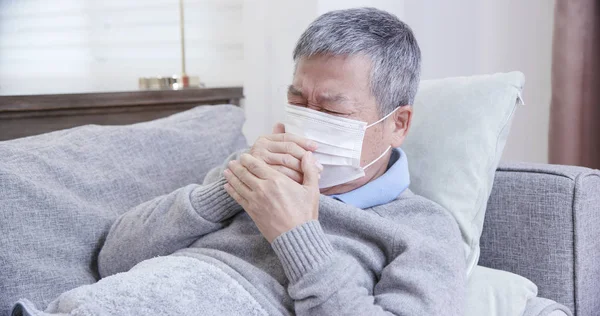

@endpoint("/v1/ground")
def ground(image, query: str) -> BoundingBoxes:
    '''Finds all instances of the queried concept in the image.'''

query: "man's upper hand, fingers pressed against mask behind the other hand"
[249,123,323,183]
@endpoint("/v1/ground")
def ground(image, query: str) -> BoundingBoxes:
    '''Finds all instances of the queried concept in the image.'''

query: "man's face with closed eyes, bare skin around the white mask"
[288,56,410,194]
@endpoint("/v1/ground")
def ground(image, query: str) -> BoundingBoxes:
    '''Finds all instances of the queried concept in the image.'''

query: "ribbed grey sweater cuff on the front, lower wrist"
[271,221,333,283]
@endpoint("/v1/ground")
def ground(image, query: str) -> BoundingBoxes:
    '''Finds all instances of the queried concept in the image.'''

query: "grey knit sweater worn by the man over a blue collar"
[98,154,466,315]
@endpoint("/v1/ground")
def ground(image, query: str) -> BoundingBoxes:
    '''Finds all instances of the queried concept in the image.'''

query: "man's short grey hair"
[294,8,421,116]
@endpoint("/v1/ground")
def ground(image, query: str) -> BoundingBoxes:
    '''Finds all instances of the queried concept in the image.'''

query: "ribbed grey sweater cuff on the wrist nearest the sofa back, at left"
[190,176,242,223]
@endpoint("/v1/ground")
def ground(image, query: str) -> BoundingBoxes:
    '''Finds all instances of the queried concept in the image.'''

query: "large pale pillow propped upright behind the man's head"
[402,72,525,275]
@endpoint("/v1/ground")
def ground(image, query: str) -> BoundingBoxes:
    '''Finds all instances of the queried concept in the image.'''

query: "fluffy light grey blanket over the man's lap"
[13,256,267,316]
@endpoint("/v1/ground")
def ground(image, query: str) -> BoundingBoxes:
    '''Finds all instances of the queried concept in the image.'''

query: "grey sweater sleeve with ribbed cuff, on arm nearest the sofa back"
[98,153,242,277]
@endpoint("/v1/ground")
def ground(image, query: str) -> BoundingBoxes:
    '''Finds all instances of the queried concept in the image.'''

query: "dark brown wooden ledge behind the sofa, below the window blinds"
[0,87,243,141]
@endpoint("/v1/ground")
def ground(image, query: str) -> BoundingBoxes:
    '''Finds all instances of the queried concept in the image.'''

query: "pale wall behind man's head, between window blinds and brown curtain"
[244,0,554,162]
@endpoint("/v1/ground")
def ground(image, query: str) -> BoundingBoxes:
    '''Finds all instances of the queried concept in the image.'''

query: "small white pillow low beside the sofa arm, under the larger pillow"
[466,266,537,316]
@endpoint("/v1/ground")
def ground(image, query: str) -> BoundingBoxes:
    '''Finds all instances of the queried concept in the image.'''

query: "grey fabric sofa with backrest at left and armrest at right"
[0,106,600,316]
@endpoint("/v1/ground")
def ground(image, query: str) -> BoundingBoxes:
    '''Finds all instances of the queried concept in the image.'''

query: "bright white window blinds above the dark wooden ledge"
[0,0,243,95]
